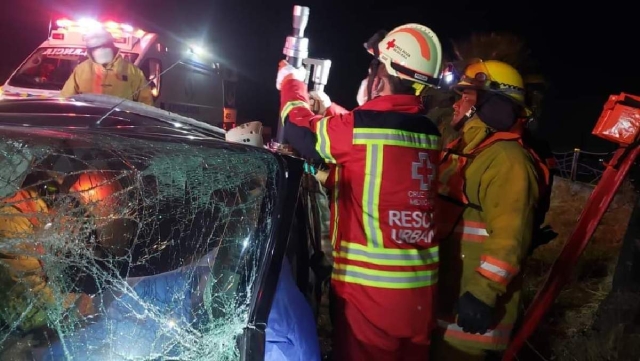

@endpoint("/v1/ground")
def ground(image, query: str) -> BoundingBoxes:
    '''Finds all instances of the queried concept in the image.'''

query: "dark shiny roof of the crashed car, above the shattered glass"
[0,94,226,140]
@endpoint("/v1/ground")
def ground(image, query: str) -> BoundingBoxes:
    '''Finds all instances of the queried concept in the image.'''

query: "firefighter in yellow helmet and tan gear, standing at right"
[432,61,549,361]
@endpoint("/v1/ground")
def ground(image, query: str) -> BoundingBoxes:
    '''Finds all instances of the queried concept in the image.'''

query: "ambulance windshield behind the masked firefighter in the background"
[9,47,138,91]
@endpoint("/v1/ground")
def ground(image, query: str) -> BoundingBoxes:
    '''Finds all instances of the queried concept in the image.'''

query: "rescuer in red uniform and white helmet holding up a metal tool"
[276,24,442,361]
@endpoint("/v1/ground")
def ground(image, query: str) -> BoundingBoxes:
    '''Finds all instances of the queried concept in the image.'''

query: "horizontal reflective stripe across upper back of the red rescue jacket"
[353,128,440,149]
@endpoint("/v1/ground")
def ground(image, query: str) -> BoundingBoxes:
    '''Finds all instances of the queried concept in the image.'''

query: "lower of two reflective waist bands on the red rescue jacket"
[331,263,438,289]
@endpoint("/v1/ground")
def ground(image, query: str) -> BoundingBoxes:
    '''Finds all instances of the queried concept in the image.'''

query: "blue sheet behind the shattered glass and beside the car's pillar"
[37,260,320,361]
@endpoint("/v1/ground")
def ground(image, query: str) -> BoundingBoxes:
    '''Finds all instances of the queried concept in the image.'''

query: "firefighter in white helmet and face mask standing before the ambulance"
[60,28,153,105]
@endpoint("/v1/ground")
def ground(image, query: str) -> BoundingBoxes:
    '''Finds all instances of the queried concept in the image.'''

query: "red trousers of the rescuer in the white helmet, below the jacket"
[331,294,430,361]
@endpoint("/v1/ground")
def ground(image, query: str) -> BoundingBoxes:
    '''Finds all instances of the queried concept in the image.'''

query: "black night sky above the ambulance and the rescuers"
[0,0,640,151]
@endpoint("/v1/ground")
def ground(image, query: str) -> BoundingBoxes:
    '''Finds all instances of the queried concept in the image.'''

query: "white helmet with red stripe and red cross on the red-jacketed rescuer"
[368,23,442,87]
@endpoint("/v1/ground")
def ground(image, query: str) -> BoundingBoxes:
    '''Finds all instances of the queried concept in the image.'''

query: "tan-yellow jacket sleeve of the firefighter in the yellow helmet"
[466,142,538,306]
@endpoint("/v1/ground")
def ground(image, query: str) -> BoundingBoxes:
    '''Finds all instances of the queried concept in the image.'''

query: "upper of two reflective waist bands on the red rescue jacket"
[337,241,439,266]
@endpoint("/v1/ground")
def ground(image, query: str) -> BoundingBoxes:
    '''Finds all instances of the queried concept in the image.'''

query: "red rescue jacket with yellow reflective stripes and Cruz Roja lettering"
[281,79,440,337]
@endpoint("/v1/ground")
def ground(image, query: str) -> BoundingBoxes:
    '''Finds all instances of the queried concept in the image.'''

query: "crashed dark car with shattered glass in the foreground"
[0,95,320,361]
